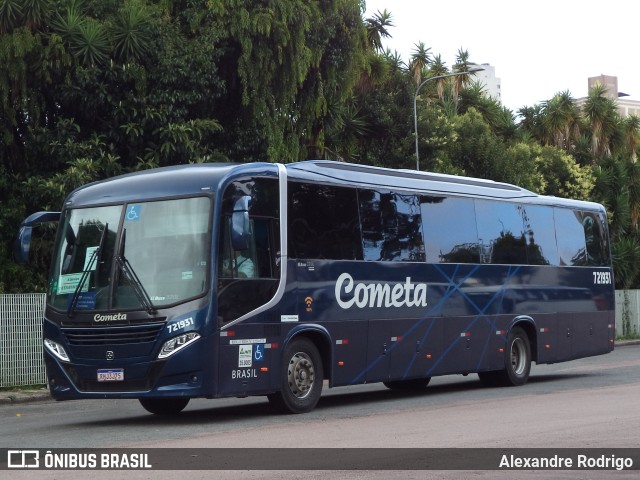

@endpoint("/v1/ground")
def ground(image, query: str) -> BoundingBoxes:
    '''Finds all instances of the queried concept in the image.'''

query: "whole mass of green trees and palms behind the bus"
[0,0,640,292]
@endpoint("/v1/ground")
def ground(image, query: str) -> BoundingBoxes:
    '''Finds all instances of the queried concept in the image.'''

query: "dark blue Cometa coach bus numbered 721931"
[18,161,615,414]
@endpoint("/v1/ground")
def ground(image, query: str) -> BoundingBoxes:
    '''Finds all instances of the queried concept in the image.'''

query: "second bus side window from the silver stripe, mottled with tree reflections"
[359,190,424,262]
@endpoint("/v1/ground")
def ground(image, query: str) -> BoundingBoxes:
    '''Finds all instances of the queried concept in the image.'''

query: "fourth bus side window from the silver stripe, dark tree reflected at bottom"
[475,200,527,264]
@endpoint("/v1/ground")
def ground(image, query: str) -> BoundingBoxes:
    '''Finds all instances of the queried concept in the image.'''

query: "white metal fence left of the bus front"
[0,293,47,387]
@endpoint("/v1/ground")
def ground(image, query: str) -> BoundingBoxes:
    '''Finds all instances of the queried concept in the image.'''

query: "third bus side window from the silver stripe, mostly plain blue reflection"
[420,196,480,263]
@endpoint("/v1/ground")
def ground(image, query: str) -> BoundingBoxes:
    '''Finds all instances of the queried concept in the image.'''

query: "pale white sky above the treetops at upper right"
[365,0,640,112]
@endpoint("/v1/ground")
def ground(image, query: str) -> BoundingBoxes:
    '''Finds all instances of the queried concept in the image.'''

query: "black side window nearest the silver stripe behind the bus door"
[289,182,362,260]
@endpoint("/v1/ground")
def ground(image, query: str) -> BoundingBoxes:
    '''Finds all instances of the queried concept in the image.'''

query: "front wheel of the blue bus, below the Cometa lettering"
[268,338,324,413]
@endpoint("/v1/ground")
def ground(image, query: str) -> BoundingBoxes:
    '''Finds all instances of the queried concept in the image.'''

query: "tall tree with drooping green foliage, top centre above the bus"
[211,0,367,161]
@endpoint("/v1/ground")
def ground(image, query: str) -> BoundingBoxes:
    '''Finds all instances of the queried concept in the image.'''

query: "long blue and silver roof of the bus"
[65,160,603,210]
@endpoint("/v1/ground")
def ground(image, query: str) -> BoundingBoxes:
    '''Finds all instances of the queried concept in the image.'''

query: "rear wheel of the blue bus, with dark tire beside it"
[478,327,531,387]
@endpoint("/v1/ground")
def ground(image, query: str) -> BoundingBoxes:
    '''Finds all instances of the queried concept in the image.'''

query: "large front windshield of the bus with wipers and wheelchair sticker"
[48,197,211,316]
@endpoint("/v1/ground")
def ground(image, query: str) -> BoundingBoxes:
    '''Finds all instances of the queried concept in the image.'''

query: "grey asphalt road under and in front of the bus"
[0,345,640,480]
